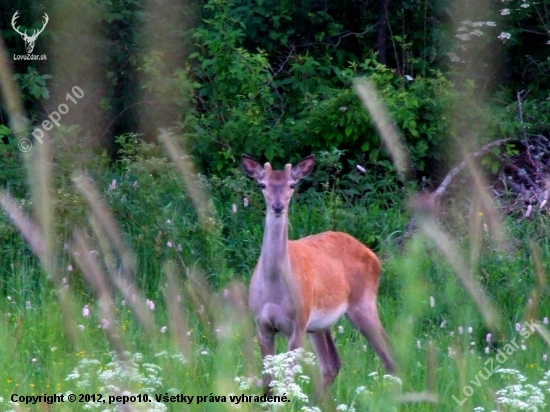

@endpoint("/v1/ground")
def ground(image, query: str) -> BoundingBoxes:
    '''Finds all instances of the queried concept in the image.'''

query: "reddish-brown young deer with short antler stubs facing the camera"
[241,154,396,398]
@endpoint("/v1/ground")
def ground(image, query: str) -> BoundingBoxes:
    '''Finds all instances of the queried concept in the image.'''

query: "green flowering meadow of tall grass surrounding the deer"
[0,136,550,411]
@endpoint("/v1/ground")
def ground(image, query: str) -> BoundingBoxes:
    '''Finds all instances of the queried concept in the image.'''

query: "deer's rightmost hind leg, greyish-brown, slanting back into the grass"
[346,296,396,374]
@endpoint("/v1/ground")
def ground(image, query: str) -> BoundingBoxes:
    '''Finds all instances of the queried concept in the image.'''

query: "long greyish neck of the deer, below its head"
[260,213,290,280]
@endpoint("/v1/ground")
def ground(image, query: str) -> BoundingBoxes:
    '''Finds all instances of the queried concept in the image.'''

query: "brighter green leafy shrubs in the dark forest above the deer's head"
[183,2,452,179]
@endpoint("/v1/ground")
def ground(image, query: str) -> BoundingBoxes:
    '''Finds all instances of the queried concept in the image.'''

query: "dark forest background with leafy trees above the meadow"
[0,0,550,181]
